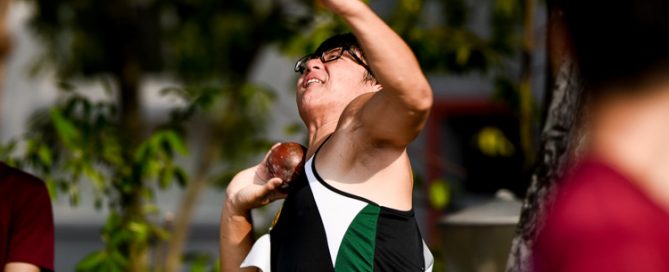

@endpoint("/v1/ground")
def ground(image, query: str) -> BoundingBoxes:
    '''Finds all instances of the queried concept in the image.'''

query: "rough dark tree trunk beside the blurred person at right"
[506,0,584,272]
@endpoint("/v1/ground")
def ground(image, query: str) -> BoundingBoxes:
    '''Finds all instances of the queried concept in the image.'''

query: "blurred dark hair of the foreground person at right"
[560,0,669,95]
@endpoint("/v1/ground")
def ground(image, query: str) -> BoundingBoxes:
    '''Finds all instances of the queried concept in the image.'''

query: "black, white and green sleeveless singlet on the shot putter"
[242,139,434,272]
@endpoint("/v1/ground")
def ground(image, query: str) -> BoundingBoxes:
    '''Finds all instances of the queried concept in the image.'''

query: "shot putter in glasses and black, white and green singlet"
[220,0,432,272]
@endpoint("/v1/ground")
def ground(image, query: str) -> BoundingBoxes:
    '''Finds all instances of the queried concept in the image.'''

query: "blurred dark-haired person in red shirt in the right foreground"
[533,0,669,272]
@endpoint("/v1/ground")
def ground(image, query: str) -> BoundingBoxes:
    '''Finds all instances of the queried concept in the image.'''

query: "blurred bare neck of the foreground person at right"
[591,85,669,210]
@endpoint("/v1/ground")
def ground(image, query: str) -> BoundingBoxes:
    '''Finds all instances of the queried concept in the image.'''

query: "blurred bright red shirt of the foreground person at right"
[533,160,669,272]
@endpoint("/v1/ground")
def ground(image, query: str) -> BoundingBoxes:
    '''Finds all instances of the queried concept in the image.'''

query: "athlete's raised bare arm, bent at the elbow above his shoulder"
[322,0,432,148]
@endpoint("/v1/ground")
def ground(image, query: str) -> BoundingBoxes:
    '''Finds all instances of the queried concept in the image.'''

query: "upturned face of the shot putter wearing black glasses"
[296,48,374,114]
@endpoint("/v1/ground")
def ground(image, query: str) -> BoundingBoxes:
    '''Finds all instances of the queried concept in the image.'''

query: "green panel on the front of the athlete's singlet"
[335,204,381,272]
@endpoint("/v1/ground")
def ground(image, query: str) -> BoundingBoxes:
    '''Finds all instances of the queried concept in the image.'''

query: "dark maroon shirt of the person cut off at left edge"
[0,162,54,270]
